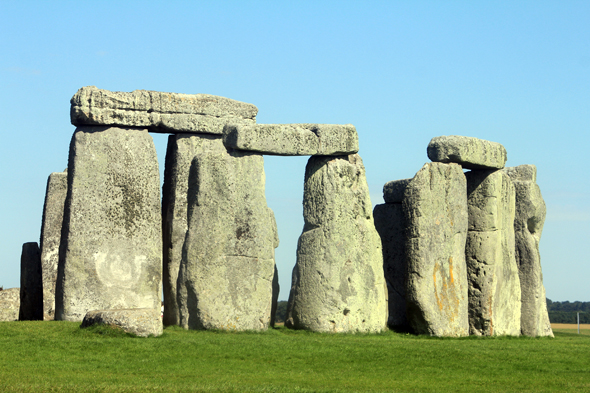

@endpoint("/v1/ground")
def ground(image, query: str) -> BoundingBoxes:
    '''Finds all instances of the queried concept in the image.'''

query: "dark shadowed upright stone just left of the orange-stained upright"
[373,202,409,329]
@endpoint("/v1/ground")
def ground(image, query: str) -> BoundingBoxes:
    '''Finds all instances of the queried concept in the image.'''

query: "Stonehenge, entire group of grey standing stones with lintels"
[13,86,552,337]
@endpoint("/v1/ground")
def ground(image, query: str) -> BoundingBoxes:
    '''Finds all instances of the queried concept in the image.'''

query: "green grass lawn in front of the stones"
[0,322,590,392]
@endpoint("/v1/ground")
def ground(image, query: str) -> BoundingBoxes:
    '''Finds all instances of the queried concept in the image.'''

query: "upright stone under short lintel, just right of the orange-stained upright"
[465,170,521,336]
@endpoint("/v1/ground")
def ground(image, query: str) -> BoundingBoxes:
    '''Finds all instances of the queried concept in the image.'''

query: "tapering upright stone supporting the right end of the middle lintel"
[285,154,387,332]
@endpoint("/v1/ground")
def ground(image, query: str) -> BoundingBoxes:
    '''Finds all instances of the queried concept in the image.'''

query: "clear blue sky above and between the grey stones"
[0,1,590,301]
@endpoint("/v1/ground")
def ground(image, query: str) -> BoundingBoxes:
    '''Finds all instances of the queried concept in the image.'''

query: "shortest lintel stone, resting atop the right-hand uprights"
[427,135,507,169]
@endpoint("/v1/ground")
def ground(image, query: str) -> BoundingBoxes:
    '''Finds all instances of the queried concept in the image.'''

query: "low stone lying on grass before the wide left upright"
[81,308,164,337]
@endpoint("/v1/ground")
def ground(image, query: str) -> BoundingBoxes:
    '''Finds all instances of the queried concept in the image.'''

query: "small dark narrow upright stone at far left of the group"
[18,242,43,321]
